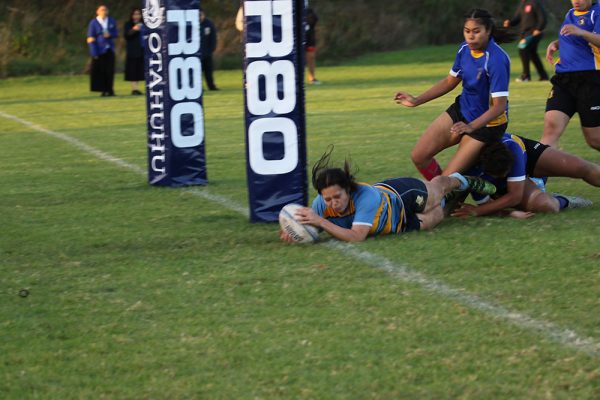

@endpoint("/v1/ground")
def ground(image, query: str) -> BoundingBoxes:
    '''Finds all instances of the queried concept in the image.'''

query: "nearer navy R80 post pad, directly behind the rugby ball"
[243,0,308,222]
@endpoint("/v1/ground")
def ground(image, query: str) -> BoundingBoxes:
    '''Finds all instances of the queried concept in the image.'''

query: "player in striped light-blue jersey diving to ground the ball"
[279,149,496,243]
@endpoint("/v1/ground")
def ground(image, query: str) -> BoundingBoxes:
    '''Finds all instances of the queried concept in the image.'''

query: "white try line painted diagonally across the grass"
[0,111,600,357]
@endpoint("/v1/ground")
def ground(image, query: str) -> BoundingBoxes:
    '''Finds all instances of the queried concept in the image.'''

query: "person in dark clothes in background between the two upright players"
[504,0,548,82]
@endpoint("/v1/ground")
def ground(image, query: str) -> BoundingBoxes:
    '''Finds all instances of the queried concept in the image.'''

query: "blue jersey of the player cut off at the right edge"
[556,4,600,73]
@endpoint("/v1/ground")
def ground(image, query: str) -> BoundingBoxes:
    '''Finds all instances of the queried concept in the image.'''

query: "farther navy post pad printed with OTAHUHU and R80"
[143,0,207,187]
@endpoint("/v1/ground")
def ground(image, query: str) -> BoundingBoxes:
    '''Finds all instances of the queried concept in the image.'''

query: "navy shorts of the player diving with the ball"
[373,178,429,232]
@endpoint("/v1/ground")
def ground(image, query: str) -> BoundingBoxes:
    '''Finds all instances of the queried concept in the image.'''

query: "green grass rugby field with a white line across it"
[0,42,600,399]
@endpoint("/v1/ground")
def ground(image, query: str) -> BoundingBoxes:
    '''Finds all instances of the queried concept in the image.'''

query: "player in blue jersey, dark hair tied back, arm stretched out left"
[395,9,510,180]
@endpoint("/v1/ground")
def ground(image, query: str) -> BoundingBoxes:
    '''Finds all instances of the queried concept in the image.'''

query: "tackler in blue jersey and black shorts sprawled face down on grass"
[452,134,600,216]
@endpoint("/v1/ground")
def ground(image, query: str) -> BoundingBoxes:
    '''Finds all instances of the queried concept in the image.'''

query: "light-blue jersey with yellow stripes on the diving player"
[312,183,406,236]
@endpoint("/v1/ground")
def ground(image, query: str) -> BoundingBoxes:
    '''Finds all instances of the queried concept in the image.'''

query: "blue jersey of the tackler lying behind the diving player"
[465,133,527,204]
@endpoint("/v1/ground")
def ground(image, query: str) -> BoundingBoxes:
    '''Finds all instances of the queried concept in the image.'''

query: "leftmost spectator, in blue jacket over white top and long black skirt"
[87,4,119,96]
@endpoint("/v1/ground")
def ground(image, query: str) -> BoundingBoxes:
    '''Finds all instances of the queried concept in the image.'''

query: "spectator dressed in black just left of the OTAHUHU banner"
[123,8,144,96]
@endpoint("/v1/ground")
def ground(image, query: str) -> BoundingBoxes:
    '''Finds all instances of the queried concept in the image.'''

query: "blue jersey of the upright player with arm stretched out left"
[450,38,510,126]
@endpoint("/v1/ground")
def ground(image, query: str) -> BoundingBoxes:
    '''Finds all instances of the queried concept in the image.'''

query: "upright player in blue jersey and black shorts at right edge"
[540,0,600,150]
